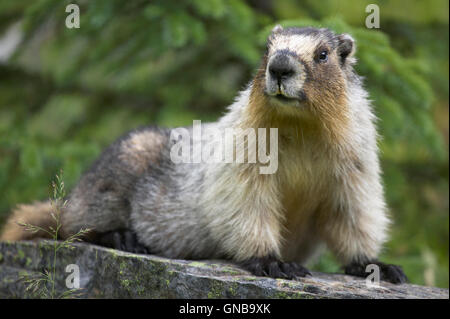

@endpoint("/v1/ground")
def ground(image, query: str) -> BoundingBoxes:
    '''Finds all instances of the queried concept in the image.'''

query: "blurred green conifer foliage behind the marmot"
[0,0,449,287]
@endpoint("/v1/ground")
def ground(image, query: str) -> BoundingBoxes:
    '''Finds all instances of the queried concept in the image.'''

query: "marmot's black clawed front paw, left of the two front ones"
[241,256,312,279]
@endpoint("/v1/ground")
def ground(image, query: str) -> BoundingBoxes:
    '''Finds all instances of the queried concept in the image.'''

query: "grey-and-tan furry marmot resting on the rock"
[1,26,407,283]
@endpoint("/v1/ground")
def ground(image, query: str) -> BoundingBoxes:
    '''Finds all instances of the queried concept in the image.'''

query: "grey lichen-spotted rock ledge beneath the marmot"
[0,241,449,299]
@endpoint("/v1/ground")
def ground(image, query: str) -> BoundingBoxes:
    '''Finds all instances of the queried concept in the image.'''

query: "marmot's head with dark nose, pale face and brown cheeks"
[253,26,356,122]
